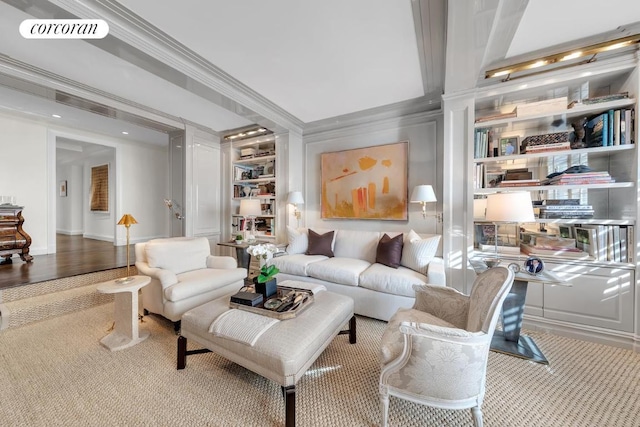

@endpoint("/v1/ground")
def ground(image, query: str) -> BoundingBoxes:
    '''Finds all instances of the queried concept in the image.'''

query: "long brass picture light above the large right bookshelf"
[484,34,640,81]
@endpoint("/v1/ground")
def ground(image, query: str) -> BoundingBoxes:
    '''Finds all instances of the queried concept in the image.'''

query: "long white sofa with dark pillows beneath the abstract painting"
[269,227,445,321]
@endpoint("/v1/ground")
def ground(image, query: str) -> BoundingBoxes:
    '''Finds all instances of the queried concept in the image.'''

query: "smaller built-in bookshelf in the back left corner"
[231,134,277,240]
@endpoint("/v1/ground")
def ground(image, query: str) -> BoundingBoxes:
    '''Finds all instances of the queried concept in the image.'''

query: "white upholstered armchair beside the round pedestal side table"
[135,237,247,330]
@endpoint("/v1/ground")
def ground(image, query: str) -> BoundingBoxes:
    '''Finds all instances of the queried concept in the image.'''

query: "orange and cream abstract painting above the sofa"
[320,142,409,221]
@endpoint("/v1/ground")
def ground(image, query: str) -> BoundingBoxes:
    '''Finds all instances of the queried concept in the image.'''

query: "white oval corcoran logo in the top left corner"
[20,19,109,39]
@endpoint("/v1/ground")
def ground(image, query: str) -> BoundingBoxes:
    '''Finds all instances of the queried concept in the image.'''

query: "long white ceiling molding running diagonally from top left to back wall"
[50,0,304,132]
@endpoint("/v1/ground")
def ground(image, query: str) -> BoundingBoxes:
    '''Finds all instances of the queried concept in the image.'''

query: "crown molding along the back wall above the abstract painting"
[303,92,442,139]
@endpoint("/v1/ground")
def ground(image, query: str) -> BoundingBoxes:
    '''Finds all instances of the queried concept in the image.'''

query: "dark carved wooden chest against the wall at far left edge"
[0,204,33,265]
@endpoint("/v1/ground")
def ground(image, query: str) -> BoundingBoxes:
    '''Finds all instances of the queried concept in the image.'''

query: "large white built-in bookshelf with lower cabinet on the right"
[466,57,640,346]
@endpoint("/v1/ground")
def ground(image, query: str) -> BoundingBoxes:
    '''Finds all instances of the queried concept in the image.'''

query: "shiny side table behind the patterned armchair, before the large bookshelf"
[470,260,564,365]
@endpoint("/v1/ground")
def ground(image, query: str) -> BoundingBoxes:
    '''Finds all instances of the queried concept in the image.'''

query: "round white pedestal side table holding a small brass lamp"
[97,276,151,351]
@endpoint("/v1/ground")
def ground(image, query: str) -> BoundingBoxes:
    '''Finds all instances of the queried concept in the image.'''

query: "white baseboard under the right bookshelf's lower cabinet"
[523,314,640,352]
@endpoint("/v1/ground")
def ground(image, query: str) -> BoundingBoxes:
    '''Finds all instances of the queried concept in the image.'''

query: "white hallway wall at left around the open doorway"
[0,114,169,255]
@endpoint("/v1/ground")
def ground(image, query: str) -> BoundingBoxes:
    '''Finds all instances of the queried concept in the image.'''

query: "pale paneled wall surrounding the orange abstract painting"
[301,116,442,237]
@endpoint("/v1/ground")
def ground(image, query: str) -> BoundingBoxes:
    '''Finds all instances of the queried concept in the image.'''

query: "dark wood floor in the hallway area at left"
[0,234,135,290]
